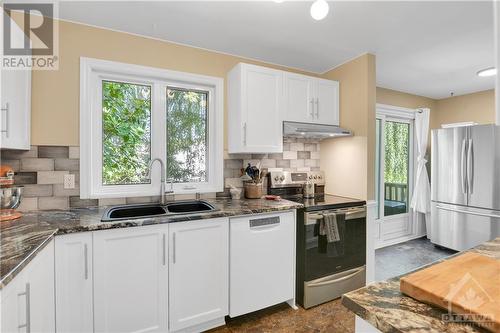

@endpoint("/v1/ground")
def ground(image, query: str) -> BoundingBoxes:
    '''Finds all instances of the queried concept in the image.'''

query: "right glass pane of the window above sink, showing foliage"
[167,88,208,182]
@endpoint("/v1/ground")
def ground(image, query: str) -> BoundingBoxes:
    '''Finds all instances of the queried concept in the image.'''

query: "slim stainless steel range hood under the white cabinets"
[283,121,353,140]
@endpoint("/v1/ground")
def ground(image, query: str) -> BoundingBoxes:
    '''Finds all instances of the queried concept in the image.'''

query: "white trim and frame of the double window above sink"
[80,57,224,199]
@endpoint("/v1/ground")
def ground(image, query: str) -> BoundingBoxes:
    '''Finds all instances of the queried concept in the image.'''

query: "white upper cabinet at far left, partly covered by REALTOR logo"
[0,24,31,149]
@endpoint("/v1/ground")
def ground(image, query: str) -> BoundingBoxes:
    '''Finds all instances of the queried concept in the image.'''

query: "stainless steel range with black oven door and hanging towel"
[267,171,366,309]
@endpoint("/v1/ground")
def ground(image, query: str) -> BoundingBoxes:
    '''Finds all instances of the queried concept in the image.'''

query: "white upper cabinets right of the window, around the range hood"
[227,63,339,153]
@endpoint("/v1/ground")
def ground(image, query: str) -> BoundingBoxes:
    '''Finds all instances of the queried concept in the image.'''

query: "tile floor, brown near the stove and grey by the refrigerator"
[209,238,455,333]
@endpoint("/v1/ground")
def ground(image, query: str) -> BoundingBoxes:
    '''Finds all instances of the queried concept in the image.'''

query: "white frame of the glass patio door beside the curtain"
[375,104,420,248]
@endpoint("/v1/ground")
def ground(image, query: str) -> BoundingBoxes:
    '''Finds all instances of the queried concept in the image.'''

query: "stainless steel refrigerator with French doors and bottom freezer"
[430,125,500,251]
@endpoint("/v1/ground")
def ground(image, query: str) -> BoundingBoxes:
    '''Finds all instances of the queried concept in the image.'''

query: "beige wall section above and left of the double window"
[31,21,314,147]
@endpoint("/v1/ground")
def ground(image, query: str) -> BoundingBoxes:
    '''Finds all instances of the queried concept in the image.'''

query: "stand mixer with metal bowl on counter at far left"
[0,165,23,221]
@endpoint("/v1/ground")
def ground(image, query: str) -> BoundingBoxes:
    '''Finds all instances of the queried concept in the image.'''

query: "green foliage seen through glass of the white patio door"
[384,121,410,184]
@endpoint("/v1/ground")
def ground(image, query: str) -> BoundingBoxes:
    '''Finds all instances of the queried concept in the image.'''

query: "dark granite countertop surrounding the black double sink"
[0,198,303,289]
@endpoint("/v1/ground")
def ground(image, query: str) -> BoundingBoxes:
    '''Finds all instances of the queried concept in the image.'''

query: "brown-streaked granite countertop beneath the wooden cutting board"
[342,238,500,333]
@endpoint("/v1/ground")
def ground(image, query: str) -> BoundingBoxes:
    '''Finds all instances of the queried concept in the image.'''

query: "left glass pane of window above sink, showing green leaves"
[102,81,151,185]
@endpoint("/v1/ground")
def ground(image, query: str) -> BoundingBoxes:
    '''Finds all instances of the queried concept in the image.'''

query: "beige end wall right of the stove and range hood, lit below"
[320,54,376,199]
